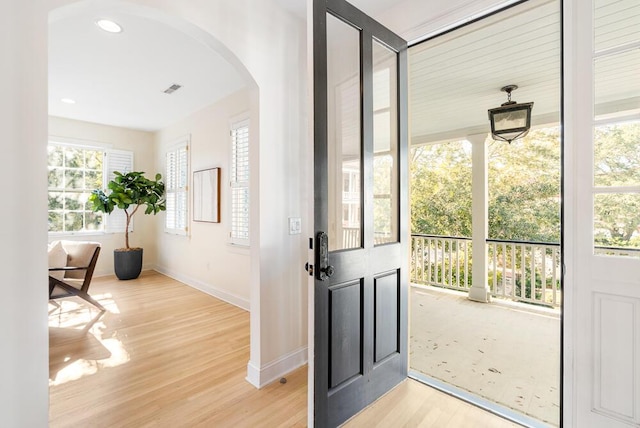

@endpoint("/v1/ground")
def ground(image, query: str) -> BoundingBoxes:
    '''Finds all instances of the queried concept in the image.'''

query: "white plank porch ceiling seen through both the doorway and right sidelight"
[409,0,640,144]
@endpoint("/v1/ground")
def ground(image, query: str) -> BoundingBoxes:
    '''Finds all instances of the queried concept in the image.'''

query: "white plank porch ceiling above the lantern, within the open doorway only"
[409,0,561,144]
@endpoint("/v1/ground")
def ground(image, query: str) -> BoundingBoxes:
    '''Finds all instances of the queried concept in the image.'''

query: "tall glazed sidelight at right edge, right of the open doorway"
[593,0,640,257]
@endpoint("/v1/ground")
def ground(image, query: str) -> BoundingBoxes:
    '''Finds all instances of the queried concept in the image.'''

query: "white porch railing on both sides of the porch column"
[411,234,562,307]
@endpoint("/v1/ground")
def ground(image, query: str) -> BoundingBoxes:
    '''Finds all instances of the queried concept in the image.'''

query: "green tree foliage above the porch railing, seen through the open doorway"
[411,128,560,242]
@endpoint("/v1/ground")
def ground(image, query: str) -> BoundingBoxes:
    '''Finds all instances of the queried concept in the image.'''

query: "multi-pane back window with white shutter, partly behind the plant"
[47,141,133,234]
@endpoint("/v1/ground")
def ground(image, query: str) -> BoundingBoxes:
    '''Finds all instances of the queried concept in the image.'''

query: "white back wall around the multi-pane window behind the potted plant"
[49,116,158,276]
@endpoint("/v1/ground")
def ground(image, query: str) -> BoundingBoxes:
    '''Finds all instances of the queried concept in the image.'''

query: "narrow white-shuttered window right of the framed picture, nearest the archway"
[230,120,249,246]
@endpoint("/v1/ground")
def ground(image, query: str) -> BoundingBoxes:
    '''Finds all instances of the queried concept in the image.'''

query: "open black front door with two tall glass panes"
[313,0,409,427]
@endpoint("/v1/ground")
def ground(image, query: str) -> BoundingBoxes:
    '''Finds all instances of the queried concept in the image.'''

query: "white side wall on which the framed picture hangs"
[155,90,251,310]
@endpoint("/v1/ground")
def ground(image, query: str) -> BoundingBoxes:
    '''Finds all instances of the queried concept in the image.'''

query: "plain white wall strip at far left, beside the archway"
[0,0,49,428]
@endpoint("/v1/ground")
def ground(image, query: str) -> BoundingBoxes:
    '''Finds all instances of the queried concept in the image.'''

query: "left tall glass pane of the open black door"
[327,15,362,251]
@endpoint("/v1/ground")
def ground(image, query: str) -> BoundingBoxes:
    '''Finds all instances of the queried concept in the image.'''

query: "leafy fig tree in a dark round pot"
[89,171,166,279]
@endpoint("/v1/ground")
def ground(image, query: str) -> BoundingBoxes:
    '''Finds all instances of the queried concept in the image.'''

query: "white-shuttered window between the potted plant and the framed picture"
[165,139,189,235]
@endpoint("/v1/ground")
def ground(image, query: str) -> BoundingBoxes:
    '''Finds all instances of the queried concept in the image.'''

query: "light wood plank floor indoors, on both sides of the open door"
[49,272,515,428]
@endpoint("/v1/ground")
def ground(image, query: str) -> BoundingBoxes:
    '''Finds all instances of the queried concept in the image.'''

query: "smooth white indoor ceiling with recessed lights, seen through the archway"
[49,7,245,131]
